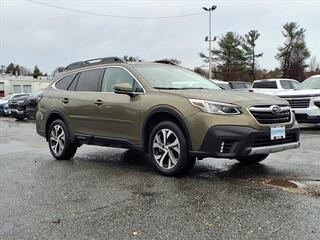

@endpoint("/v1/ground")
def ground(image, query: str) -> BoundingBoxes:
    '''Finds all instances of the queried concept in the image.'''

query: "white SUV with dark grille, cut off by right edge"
[277,75,320,123]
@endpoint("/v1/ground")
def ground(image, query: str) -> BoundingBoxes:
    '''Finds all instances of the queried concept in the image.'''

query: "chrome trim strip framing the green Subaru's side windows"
[51,66,147,95]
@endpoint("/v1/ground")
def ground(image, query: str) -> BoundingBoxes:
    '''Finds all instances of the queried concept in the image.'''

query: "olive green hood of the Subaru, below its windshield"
[161,89,288,105]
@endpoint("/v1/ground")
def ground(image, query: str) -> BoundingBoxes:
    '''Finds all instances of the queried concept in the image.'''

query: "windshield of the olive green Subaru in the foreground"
[134,64,221,90]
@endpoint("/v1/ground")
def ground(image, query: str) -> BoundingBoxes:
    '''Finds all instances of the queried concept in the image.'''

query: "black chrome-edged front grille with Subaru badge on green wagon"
[249,105,291,124]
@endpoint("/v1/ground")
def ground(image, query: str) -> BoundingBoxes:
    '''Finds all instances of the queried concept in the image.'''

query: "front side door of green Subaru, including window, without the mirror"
[96,67,144,143]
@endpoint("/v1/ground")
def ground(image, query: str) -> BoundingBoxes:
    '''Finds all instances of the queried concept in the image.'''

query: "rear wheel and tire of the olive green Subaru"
[48,119,77,160]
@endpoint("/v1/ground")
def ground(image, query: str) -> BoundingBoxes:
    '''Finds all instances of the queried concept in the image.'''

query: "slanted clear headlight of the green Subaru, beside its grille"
[189,99,241,115]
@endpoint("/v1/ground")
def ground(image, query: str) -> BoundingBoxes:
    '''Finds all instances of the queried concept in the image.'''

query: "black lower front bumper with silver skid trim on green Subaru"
[190,124,300,159]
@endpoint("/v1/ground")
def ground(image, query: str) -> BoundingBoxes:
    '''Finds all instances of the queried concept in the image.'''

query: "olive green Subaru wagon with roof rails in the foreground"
[36,58,299,176]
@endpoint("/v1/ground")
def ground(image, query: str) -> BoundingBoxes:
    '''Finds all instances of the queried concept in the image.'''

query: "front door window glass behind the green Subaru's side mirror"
[101,67,142,92]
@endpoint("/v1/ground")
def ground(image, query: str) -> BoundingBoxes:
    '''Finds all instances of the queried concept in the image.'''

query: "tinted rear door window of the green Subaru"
[76,68,104,92]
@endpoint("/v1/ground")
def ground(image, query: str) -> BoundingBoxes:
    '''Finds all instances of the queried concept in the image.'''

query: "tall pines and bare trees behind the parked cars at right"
[199,22,320,81]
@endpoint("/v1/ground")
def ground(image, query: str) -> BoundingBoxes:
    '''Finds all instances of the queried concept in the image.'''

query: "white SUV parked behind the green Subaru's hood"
[249,78,302,95]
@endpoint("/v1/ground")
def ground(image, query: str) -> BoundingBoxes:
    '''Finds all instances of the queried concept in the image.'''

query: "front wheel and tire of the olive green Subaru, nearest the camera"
[148,121,196,176]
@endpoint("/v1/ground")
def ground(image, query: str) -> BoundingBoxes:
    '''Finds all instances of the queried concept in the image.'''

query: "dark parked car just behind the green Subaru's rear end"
[9,90,42,120]
